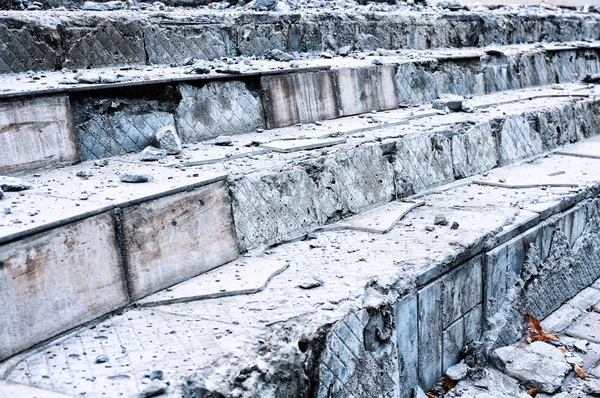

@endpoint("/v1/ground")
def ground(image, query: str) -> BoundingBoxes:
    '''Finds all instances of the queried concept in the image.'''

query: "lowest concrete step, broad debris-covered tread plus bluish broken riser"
[2,134,600,397]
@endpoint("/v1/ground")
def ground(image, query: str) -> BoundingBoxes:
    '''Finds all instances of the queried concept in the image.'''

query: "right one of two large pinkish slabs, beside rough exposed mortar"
[122,182,238,299]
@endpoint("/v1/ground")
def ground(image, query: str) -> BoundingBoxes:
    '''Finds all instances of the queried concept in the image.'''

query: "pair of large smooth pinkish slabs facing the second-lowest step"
[0,182,238,360]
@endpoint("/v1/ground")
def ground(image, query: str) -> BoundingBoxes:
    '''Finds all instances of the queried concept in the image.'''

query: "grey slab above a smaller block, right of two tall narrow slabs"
[442,256,483,328]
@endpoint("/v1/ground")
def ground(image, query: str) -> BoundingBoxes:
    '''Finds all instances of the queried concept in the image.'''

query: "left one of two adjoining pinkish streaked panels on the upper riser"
[261,71,339,128]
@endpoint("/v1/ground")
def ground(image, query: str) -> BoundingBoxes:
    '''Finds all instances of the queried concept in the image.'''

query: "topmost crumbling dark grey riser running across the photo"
[0,11,600,73]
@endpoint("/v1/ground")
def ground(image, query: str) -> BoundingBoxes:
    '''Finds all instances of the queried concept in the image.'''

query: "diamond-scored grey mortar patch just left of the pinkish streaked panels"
[175,80,265,142]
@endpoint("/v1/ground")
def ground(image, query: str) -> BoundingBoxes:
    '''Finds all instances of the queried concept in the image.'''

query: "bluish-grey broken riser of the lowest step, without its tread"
[317,198,600,398]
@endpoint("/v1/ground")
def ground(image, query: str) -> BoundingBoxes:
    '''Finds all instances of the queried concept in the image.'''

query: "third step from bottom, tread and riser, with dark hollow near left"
[0,42,600,174]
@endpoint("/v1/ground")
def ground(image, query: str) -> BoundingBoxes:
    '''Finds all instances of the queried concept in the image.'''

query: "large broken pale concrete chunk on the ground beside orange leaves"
[491,341,571,393]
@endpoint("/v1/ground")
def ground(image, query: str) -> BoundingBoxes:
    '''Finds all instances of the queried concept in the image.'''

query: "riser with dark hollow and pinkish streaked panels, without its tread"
[0,49,600,174]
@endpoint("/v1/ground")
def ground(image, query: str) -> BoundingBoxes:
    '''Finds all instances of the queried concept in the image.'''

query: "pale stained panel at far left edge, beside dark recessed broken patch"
[0,96,79,174]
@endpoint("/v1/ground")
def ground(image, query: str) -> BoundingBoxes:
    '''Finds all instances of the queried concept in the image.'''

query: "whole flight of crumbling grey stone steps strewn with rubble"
[0,4,600,397]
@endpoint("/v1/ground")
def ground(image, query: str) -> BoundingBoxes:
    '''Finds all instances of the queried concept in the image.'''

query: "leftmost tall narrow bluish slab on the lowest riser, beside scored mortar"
[394,293,419,398]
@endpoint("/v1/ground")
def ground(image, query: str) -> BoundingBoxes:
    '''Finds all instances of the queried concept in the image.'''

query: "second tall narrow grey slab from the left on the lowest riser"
[417,281,442,390]
